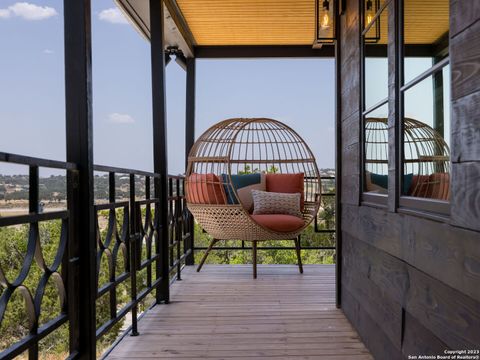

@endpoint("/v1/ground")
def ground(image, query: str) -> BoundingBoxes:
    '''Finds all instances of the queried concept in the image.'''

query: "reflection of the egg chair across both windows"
[365,118,450,200]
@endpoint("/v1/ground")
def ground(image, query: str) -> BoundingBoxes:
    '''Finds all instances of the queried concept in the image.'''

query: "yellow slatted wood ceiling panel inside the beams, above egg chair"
[177,0,315,45]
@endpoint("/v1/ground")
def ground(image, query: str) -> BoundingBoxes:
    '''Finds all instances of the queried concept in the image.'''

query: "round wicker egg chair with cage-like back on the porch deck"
[185,118,321,278]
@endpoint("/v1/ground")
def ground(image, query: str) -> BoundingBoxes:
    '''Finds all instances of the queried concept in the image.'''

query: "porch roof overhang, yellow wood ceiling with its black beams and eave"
[116,0,334,58]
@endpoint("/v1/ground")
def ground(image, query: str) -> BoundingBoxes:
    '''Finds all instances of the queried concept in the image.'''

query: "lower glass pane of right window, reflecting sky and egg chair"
[403,66,450,200]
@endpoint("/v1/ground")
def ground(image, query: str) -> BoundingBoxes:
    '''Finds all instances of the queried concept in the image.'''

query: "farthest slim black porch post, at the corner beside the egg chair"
[185,58,196,265]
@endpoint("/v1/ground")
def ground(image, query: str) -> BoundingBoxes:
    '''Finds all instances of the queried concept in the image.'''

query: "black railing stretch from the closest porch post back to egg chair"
[94,165,192,340]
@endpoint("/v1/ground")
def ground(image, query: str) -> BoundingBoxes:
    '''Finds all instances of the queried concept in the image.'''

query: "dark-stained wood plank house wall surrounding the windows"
[340,0,480,359]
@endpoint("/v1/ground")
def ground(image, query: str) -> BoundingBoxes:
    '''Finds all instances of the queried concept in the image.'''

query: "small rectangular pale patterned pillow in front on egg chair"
[252,190,302,217]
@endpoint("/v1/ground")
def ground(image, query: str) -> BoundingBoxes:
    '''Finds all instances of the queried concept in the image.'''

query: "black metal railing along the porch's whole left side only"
[0,153,192,359]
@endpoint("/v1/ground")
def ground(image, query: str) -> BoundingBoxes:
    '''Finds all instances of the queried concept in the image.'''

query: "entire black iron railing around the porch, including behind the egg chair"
[0,153,335,359]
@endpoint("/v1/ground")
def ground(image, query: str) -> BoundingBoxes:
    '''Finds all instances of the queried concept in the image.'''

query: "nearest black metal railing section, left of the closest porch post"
[0,153,77,359]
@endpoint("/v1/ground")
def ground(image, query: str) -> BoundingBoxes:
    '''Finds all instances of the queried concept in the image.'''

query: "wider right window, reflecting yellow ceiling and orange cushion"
[399,0,450,212]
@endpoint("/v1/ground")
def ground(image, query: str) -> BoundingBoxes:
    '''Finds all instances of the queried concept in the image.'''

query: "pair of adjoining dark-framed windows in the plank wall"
[360,0,451,213]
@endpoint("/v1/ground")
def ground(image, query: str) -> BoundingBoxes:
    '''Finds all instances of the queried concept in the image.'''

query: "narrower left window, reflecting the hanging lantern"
[361,0,389,203]
